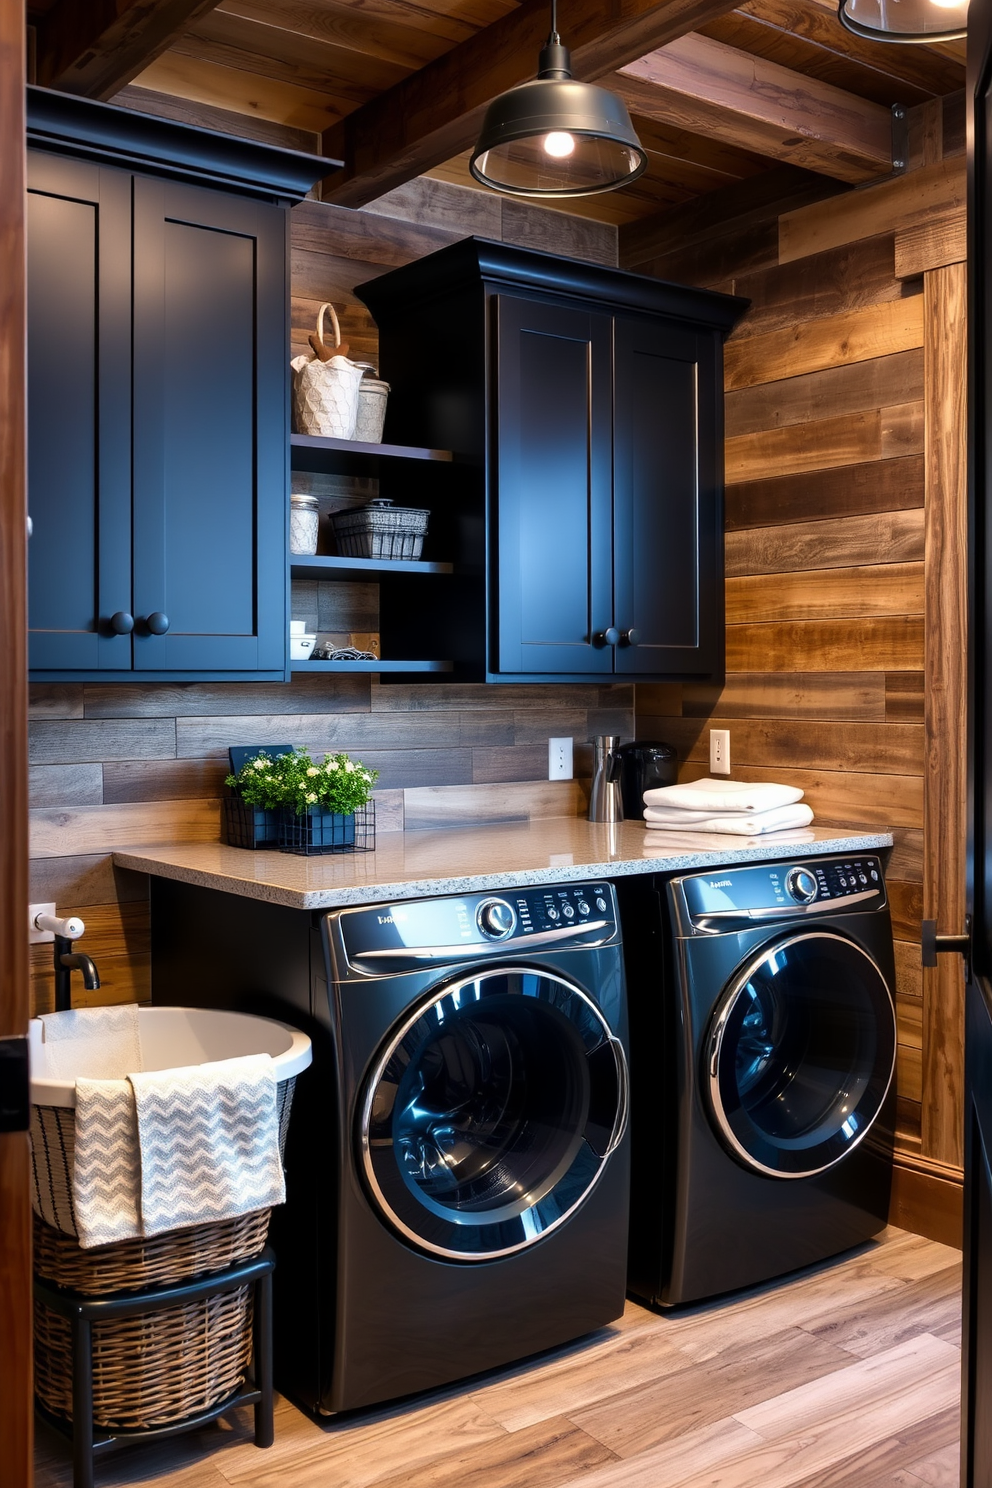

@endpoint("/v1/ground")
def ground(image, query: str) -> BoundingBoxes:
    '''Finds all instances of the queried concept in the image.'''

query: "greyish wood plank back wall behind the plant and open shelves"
[30,180,634,1012]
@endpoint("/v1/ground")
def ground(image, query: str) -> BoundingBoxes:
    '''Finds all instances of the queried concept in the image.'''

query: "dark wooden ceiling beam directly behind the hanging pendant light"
[323,0,749,207]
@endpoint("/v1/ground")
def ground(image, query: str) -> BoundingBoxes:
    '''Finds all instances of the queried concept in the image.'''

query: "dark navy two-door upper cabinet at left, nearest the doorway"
[28,94,325,682]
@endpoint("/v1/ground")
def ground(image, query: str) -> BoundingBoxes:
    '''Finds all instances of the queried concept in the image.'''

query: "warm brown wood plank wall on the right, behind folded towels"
[635,97,965,1240]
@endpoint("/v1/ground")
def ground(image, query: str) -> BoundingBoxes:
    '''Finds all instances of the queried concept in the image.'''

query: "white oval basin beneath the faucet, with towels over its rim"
[28,1007,312,1106]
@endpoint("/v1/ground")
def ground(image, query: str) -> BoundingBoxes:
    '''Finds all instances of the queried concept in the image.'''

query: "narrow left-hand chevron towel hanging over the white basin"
[73,1080,141,1250]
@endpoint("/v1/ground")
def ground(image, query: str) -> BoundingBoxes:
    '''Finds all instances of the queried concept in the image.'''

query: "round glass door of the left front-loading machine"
[358,967,628,1260]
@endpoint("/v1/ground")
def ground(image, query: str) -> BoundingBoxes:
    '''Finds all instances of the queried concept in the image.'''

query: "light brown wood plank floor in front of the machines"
[36,1229,961,1488]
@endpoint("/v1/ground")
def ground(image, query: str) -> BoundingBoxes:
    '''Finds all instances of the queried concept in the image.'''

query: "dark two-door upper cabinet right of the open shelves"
[358,238,747,682]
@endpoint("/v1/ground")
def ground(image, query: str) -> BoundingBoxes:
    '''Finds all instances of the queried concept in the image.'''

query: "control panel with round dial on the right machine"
[671,854,885,934]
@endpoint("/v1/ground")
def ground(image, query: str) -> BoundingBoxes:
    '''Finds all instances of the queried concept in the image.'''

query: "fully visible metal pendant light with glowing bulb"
[468,0,647,196]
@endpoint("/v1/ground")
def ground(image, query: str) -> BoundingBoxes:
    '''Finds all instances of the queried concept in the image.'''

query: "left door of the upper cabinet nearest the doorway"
[28,152,131,671]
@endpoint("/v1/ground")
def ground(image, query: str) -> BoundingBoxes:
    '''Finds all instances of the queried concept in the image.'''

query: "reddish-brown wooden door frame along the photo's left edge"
[0,0,33,1488]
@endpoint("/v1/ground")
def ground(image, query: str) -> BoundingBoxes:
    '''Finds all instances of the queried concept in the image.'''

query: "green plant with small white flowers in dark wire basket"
[228,748,379,854]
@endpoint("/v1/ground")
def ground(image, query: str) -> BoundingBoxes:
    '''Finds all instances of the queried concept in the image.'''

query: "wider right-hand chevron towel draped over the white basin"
[129,1054,286,1235]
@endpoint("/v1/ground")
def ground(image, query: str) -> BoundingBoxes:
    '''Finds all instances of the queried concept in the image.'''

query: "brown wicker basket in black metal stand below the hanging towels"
[34,1210,269,1430]
